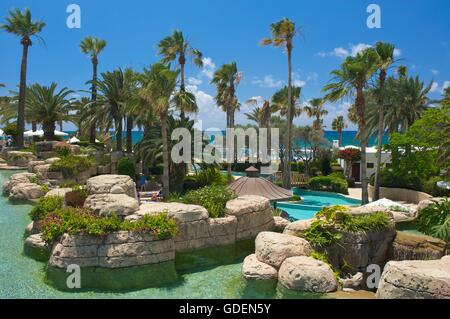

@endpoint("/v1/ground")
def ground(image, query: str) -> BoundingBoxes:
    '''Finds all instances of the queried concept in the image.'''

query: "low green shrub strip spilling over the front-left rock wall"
[41,208,178,243]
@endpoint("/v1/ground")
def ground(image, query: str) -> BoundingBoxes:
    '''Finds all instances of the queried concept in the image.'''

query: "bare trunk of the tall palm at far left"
[16,39,29,148]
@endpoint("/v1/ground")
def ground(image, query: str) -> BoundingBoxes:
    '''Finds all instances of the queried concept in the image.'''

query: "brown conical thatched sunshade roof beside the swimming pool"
[228,167,294,201]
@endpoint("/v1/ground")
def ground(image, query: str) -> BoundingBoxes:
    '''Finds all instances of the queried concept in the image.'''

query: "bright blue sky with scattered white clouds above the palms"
[0,0,450,129]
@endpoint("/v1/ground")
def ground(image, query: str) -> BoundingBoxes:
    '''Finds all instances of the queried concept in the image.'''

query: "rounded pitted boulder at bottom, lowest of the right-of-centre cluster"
[278,256,338,293]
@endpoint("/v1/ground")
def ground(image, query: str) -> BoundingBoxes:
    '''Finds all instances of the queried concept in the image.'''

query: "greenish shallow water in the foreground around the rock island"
[0,171,320,299]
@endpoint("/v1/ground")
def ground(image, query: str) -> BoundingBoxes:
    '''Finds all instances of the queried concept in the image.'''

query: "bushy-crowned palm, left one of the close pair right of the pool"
[323,49,378,204]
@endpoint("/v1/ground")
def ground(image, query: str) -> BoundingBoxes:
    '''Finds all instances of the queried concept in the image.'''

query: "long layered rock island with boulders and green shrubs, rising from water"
[21,173,278,289]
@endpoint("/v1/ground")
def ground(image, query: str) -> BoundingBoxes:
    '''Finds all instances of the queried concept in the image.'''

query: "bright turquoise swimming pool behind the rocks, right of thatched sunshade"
[277,188,361,220]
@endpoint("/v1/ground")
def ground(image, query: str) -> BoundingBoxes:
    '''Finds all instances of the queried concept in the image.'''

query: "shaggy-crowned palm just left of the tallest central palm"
[211,62,241,180]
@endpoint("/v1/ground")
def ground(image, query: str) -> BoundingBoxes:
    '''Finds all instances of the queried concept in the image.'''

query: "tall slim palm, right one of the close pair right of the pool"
[373,42,395,201]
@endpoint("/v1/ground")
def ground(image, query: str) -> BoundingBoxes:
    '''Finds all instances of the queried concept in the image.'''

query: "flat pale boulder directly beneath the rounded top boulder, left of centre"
[84,194,139,216]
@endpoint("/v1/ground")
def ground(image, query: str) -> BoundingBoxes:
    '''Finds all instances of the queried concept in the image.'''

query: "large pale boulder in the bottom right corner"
[376,256,450,299]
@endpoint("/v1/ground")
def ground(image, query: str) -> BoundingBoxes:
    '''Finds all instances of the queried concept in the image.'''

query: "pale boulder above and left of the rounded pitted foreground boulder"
[255,232,312,268]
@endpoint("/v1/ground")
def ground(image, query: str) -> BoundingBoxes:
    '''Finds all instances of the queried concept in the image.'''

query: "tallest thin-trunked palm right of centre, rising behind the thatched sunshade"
[261,18,298,188]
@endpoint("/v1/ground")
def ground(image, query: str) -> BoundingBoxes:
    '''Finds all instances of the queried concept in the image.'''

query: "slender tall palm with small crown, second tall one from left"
[80,37,106,143]
